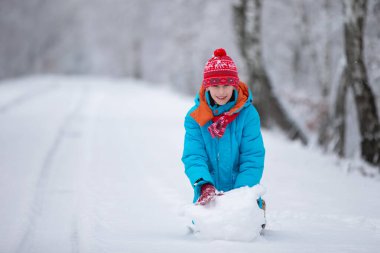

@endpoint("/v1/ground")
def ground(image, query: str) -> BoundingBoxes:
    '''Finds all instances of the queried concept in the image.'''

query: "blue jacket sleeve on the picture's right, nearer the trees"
[234,106,265,188]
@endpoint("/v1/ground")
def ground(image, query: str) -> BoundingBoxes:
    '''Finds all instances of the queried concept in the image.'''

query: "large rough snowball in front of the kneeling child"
[185,185,265,241]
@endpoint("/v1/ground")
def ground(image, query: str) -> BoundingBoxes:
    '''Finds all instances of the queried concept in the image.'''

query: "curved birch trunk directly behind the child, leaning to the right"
[234,0,308,144]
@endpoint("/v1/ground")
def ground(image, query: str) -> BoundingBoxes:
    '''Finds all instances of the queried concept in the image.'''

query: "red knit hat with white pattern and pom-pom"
[203,48,239,88]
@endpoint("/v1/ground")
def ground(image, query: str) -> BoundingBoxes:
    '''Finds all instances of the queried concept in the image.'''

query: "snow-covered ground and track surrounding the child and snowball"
[0,77,380,253]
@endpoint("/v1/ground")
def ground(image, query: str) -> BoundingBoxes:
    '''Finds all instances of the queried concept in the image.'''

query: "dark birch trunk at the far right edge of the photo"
[344,0,380,166]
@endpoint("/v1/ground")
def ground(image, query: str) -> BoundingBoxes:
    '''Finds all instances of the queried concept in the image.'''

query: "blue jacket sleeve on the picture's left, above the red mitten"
[182,115,214,202]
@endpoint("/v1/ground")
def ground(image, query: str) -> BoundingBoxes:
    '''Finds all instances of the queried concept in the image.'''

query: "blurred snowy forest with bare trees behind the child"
[0,0,380,170]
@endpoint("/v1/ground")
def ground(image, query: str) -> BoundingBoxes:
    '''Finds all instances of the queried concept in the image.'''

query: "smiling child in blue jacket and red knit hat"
[182,48,265,208]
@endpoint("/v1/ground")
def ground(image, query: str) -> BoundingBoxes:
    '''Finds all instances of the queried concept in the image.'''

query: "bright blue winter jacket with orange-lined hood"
[182,83,265,202]
